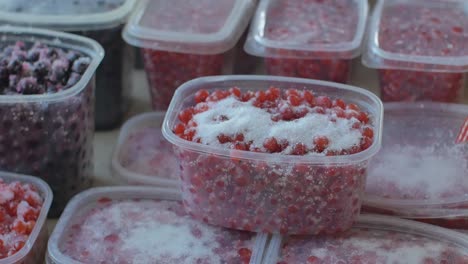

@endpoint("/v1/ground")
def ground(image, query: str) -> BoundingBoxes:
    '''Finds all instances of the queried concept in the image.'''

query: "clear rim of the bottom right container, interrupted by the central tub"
[264,214,468,263]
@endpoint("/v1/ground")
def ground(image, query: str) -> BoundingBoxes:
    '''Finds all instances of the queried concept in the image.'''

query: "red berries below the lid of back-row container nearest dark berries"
[142,49,224,110]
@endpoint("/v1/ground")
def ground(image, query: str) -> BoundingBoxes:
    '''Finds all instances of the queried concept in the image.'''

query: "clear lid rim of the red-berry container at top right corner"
[362,0,468,72]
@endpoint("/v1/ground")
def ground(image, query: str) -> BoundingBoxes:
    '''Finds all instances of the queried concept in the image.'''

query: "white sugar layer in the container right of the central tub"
[366,145,468,199]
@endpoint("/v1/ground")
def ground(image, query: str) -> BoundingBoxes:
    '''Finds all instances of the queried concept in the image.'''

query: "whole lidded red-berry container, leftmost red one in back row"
[123,0,254,110]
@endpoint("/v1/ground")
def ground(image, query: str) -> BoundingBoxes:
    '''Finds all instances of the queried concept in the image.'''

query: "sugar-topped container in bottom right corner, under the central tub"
[263,215,468,264]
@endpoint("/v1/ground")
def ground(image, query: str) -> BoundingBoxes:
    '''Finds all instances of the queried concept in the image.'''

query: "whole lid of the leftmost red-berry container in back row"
[123,0,255,54]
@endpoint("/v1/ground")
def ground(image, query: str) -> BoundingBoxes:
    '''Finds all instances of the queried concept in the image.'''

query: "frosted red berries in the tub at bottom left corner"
[0,179,43,259]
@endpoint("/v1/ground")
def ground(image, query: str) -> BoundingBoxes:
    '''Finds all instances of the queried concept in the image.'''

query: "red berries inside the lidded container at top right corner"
[379,3,468,102]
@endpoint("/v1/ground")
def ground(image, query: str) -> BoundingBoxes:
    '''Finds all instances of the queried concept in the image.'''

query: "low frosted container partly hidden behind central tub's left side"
[112,112,179,188]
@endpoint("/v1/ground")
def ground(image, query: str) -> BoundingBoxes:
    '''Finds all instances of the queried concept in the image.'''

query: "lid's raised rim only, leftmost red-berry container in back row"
[122,0,254,55]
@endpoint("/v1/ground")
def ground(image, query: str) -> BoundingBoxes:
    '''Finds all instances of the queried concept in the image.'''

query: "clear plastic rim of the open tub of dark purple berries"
[0,25,104,103]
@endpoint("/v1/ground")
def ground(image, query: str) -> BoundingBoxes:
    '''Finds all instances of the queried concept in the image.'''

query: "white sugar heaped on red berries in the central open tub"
[194,97,361,152]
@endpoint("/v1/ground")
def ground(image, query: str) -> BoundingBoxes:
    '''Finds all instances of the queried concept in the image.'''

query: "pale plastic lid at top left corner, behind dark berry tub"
[0,0,137,31]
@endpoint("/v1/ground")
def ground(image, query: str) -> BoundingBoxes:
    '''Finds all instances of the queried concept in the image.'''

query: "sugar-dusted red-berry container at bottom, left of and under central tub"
[47,186,267,264]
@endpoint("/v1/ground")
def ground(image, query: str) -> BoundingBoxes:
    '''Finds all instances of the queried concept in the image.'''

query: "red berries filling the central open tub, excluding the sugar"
[173,88,374,234]
